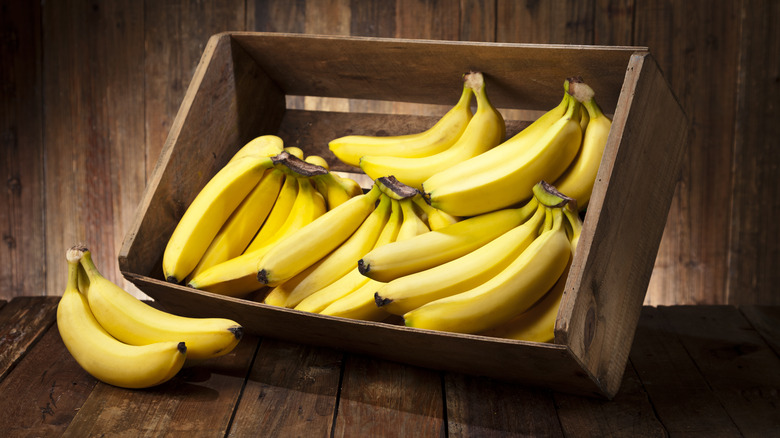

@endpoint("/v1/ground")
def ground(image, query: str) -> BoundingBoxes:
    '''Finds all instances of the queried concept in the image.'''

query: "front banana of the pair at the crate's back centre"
[360,72,506,188]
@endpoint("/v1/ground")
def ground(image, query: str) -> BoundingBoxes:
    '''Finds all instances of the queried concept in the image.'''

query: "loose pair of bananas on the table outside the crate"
[57,246,243,388]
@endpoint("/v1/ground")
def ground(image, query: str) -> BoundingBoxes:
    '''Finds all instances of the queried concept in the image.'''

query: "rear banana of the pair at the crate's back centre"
[328,78,473,167]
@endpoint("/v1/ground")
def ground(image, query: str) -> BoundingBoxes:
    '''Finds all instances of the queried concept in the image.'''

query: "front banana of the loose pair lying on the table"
[57,250,187,389]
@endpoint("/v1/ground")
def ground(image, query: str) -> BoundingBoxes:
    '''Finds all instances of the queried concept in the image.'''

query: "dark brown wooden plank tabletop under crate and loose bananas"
[0,297,780,438]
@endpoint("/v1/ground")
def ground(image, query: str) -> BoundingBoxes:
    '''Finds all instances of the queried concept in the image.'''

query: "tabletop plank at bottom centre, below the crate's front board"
[332,355,446,437]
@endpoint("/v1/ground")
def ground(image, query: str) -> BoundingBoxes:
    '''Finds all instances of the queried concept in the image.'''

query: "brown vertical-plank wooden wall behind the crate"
[0,0,780,305]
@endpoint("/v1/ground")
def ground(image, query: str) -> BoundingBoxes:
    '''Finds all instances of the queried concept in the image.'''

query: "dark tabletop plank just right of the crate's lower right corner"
[630,307,739,437]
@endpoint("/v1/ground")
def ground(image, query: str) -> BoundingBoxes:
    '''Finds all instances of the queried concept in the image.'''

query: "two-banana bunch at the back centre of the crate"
[329,72,506,189]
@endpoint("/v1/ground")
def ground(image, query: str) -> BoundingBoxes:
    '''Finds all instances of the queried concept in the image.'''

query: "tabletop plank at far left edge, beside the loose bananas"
[0,297,59,380]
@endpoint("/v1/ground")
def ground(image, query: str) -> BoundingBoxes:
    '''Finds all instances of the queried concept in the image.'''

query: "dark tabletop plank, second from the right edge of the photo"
[661,306,780,437]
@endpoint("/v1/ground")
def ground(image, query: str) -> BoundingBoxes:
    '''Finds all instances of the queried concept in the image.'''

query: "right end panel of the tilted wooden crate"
[556,55,688,393]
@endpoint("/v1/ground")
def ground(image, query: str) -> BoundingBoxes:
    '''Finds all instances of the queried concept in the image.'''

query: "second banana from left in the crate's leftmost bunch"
[187,169,284,281]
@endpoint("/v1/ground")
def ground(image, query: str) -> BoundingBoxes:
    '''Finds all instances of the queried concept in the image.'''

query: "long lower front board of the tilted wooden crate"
[123,272,604,397]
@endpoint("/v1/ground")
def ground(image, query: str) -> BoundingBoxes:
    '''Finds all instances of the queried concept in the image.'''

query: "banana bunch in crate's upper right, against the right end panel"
[421,78,611,216]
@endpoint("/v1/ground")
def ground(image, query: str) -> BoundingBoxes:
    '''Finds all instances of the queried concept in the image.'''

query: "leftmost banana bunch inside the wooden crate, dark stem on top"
[163,135,363,296]
